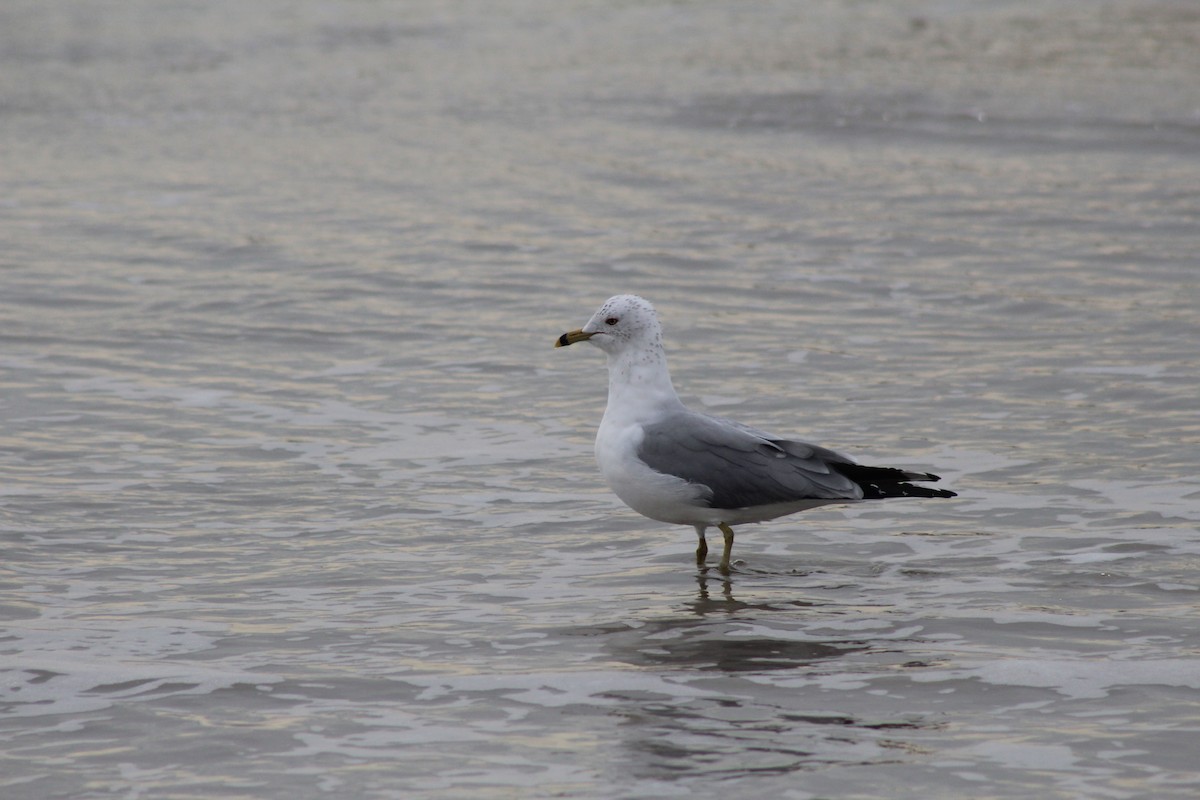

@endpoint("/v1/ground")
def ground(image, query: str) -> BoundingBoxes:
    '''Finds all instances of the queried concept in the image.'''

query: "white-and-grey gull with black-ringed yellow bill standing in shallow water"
[554,295,955,576]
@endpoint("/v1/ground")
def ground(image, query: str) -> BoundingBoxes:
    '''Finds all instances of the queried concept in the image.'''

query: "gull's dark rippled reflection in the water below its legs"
[590,594,926,781]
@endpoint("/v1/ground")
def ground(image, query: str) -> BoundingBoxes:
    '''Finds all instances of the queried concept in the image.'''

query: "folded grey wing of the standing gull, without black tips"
[637,411,863,509]
